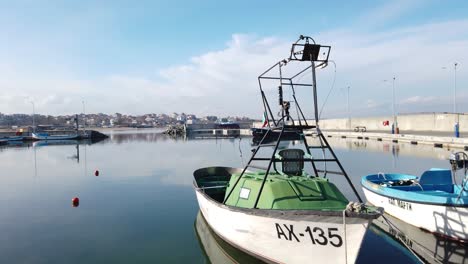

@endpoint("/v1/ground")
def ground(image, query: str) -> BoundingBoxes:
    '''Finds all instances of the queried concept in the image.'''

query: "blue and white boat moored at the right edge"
[361,152,468,243]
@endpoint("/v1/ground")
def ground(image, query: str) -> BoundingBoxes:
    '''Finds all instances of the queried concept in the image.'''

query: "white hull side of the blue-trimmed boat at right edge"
[363,188,468,241]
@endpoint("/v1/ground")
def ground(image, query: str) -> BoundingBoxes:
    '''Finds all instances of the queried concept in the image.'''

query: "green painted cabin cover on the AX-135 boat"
[225,173,348,210]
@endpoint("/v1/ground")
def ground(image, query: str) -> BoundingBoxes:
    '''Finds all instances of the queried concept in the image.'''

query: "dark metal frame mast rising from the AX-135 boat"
[223,35,362,204]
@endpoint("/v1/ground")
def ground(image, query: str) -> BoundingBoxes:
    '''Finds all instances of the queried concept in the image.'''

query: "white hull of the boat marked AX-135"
[196,190,371,263]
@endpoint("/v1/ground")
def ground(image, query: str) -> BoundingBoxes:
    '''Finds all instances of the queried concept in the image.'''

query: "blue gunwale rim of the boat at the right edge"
[361,177,468,208]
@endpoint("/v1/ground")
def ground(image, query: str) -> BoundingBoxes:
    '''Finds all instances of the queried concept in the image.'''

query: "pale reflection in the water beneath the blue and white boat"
[371,214,468,263]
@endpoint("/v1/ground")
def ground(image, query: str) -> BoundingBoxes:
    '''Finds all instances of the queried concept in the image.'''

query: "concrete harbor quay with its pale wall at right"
[245,112,468,150]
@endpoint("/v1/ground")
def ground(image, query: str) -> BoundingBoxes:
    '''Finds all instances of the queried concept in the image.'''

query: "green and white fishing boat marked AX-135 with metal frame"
[194,36,382,263]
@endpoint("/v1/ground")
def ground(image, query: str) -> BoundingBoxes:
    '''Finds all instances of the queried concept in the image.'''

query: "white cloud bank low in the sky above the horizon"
[0,17,468,117]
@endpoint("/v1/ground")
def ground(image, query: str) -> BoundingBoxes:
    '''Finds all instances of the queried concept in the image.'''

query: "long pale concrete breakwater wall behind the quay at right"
[320,113,468,132]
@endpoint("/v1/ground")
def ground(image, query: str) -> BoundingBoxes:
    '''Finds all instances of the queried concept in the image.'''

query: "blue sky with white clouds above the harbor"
[0,0,468,118]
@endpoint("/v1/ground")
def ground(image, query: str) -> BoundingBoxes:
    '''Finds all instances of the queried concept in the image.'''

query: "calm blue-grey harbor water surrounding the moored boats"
[0,130,464,263]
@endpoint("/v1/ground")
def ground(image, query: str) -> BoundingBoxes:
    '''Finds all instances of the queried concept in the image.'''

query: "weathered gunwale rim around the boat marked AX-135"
[193,166,383,220]
